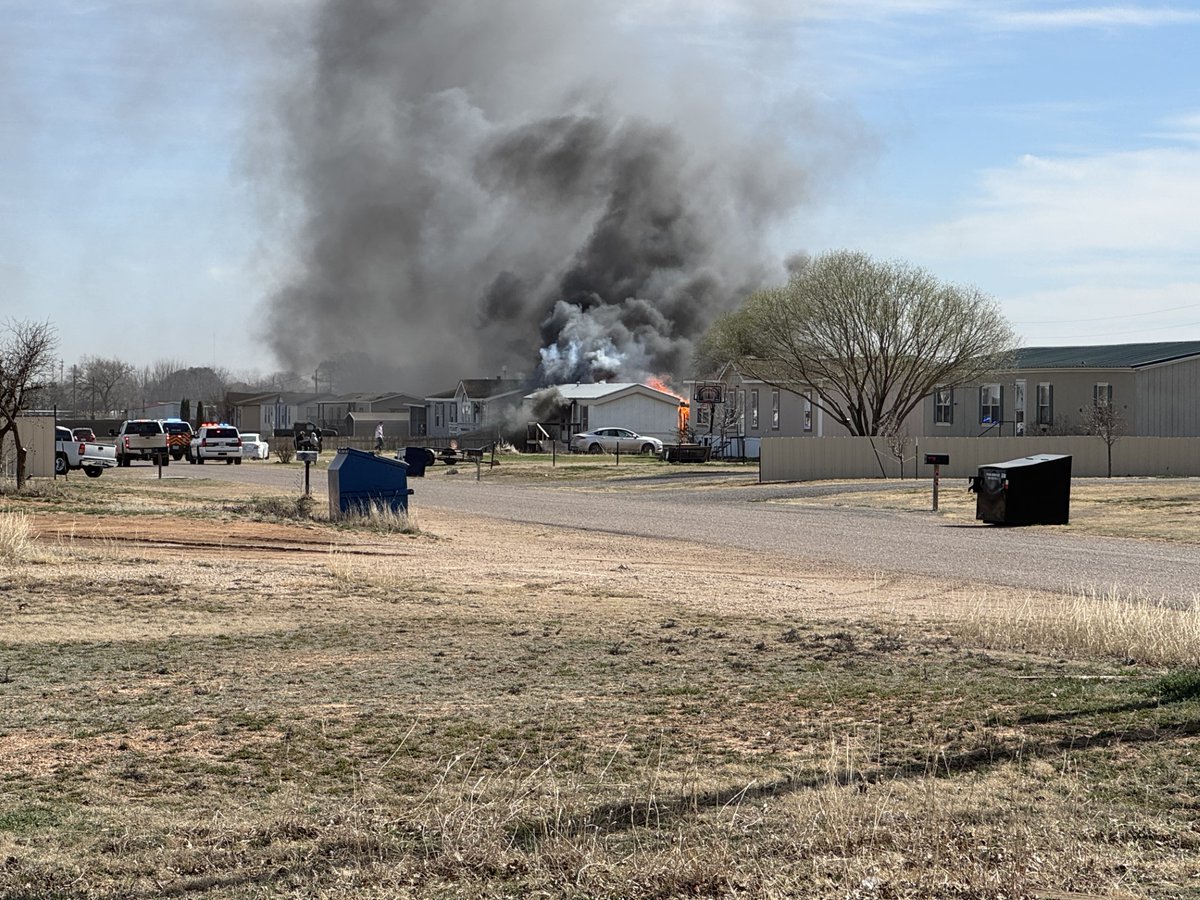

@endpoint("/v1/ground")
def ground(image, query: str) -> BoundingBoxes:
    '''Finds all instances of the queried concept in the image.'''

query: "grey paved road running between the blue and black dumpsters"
[114,463,1200,605]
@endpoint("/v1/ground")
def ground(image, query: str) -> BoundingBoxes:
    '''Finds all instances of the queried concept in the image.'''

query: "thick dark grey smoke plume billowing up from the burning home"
[259,0,849,390]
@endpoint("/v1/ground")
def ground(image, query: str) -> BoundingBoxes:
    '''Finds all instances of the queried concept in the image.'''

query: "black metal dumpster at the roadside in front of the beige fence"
[968,454,1070,524]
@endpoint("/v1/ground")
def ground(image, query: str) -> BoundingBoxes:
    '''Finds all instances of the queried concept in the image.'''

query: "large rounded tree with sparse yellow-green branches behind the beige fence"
[700,251,1016,436]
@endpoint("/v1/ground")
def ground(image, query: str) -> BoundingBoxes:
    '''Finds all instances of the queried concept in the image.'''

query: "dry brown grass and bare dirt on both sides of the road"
[0,475,1200,900]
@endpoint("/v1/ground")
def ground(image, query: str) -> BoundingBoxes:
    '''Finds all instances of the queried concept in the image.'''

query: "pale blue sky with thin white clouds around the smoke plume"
[0,0,1200,373]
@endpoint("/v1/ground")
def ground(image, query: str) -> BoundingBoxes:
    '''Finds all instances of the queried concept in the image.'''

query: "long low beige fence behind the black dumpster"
[760,434,1200,481]
